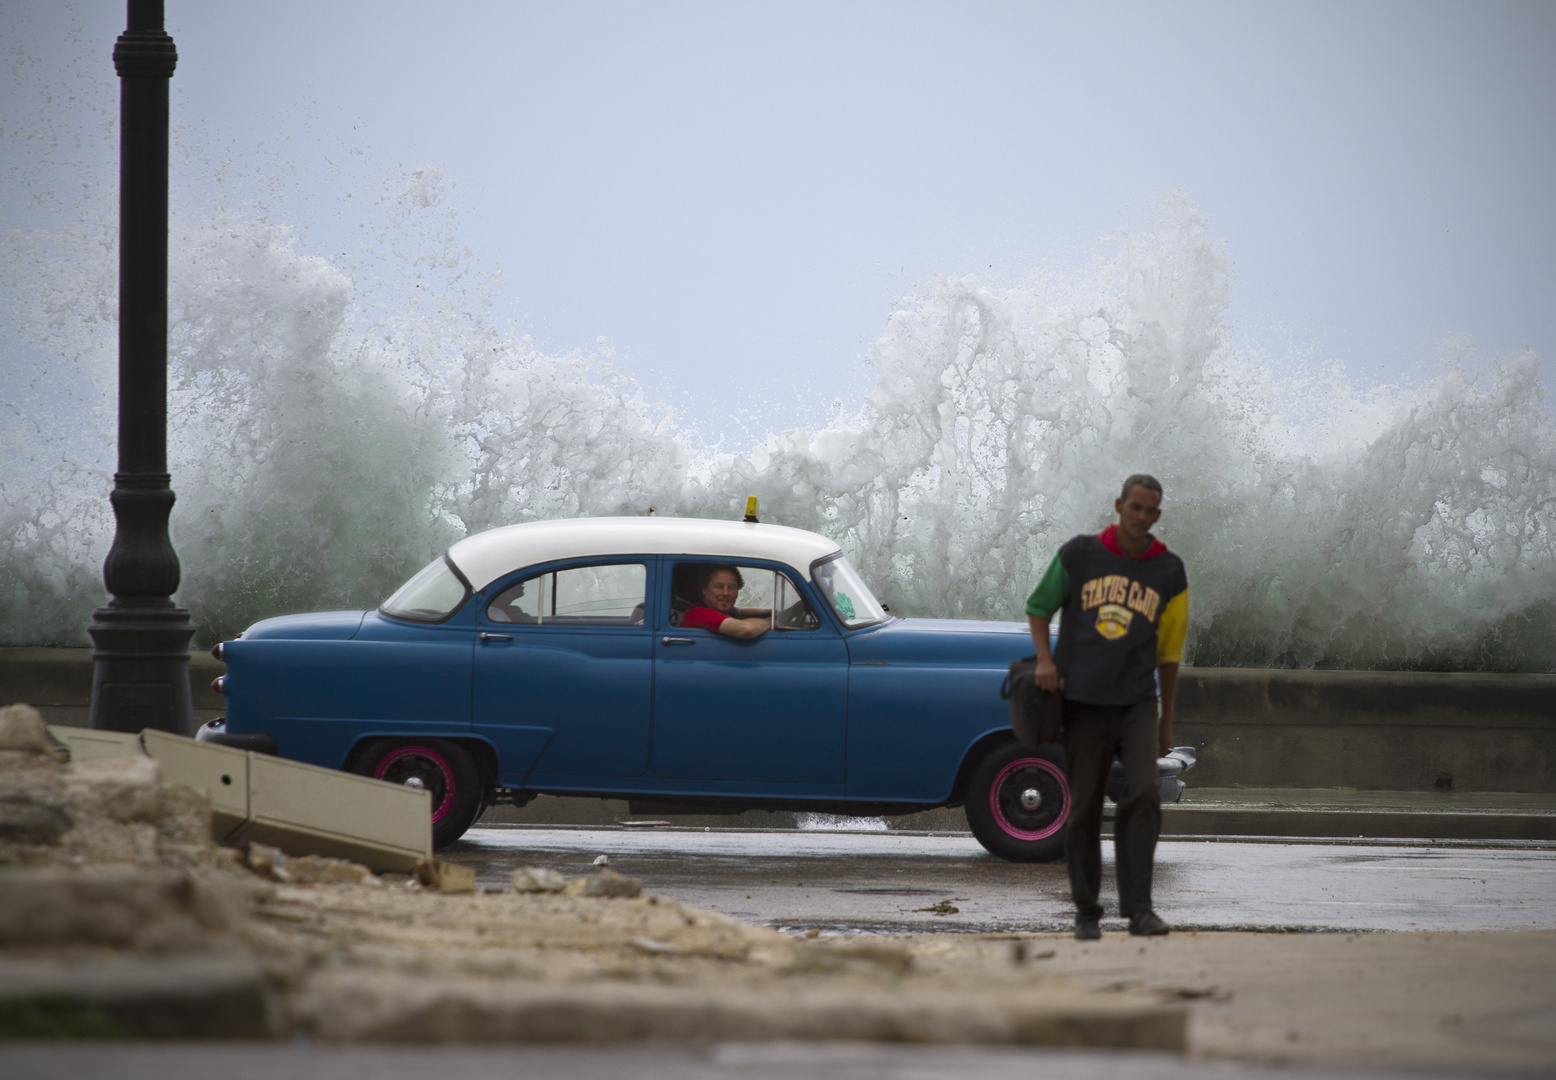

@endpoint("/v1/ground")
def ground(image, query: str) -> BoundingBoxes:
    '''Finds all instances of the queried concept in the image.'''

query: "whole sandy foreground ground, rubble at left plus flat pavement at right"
[0,707,1556,1068]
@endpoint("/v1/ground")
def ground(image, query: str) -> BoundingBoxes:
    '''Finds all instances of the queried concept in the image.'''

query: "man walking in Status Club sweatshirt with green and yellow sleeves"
[1027,473,1189,941]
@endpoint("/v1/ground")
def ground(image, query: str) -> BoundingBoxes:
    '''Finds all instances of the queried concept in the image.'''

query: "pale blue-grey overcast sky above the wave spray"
[0,0,1556,438]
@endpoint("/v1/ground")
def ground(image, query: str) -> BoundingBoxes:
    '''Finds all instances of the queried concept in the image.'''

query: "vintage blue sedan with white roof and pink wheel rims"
[201,517,1192,861]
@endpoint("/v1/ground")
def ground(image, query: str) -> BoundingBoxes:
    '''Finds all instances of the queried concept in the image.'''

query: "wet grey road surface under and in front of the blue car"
[443,826,1556,932]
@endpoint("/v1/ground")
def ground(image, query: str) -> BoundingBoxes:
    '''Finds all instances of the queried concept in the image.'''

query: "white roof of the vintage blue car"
[448,517,839,590]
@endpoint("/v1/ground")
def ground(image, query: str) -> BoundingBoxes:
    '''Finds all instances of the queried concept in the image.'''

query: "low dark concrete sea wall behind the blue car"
[0,649,1556,792]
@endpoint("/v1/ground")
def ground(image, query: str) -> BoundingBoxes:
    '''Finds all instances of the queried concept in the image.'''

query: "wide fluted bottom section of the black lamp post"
[87,601,195,736]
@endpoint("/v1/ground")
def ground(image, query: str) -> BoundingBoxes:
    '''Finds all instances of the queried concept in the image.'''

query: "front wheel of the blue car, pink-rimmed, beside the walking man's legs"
[962,742,1072,862]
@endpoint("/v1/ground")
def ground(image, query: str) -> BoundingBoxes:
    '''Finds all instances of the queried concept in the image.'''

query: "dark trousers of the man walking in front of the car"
[1064,697,1162,918]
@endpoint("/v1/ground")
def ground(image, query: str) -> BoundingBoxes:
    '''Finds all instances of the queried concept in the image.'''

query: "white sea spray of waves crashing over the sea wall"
[0,54,1556,671]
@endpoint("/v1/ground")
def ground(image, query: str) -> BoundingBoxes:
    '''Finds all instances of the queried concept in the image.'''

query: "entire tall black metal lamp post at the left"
[87,0,195,735]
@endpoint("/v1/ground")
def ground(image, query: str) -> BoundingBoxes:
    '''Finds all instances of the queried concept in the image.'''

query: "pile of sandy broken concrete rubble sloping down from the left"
[0,705,1187,1050]
